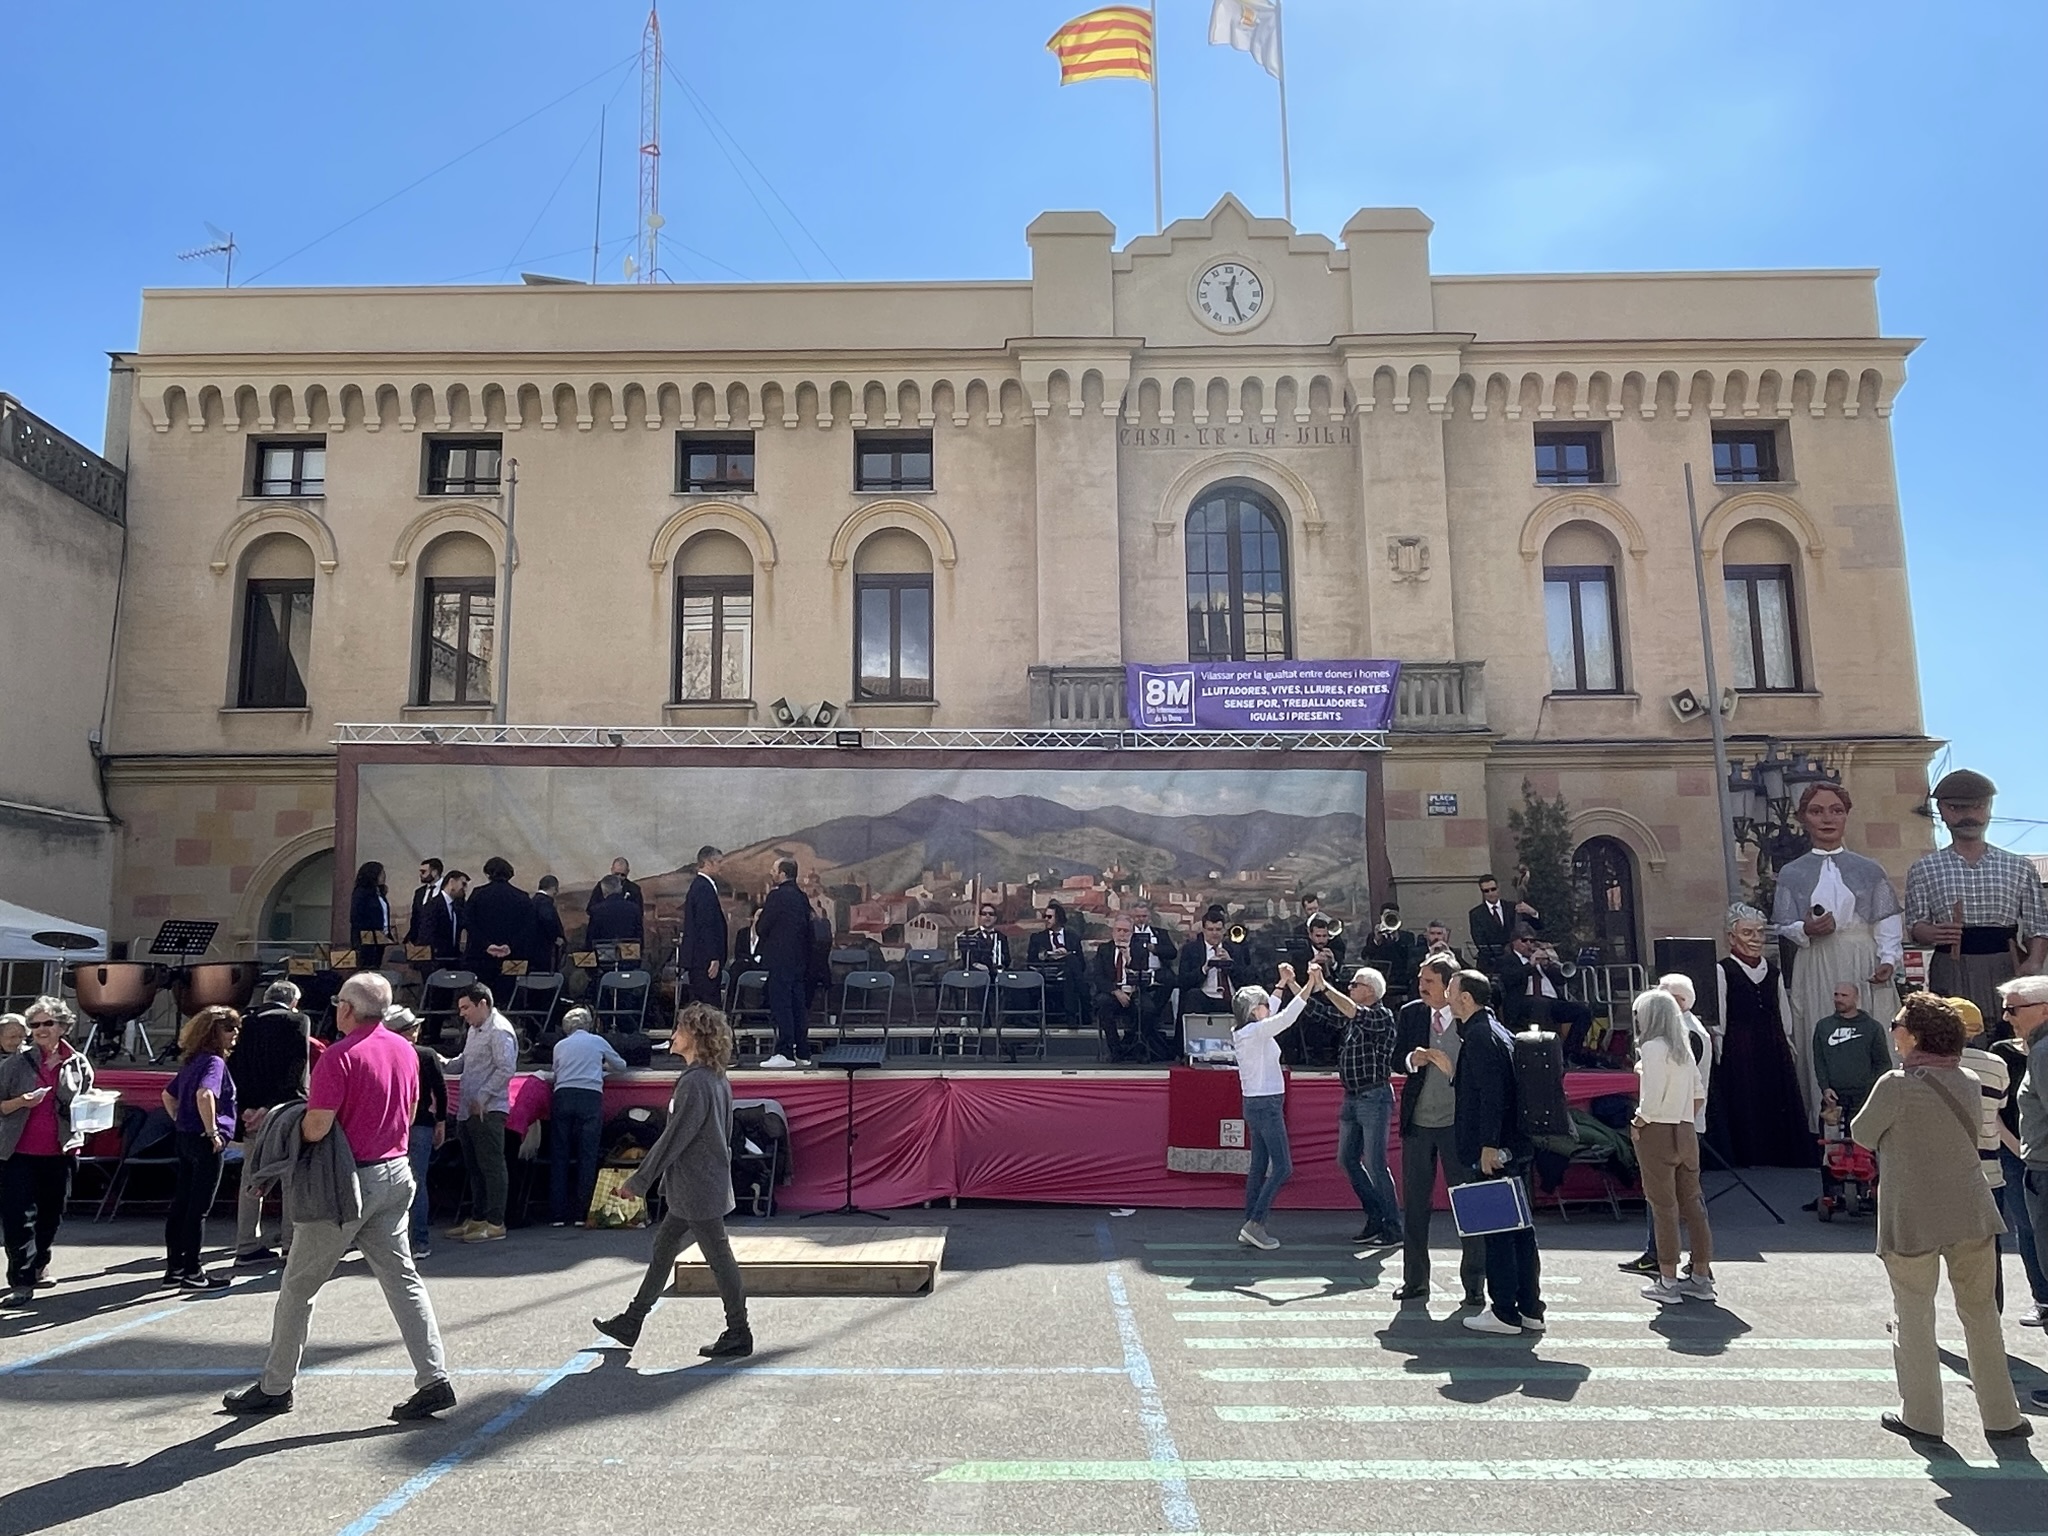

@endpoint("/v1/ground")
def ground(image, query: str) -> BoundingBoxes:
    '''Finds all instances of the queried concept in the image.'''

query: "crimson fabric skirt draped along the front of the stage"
[98,1069,1636,1210]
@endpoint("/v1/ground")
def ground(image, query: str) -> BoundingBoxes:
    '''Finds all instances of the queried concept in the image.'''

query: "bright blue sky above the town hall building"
[0,0,2048,850]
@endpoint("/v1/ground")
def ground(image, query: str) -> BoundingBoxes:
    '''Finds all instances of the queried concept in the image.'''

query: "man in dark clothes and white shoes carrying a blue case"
[1450,971,1544,1333]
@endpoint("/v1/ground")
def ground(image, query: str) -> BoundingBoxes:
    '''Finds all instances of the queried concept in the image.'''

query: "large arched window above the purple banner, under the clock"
[1188,485,1294,662]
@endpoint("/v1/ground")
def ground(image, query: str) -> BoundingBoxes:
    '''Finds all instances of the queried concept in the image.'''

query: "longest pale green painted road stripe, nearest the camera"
[928,1456,2048,1483]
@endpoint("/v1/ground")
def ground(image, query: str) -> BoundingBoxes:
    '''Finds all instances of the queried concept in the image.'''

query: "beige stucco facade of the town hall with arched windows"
[109,199,1931,958]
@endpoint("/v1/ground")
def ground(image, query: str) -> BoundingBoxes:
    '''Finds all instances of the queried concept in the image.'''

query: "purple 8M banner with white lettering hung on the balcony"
[1124,662,1401,731]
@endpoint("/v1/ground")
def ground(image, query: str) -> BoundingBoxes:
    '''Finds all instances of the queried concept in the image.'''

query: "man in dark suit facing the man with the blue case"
[1395,958,1487,1309]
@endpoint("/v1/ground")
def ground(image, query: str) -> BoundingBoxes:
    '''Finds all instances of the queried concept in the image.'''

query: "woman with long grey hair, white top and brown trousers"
[1628,989,1714,1307]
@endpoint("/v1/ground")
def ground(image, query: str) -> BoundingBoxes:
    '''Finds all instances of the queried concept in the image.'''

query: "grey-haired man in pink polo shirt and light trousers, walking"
[221,971,455,1419]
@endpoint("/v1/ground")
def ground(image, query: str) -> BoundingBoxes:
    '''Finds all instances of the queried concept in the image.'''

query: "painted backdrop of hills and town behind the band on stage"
[356,764,1370,950]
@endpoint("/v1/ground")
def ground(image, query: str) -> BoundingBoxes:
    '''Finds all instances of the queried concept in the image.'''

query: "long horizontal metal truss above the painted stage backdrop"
[334,721,1386,752]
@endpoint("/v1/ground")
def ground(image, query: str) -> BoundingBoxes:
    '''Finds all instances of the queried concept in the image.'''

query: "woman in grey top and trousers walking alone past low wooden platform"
[592,1004,754,1360]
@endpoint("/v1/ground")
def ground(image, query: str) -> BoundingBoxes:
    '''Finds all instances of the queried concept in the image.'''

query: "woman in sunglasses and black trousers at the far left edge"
[0,997,92,1307]
